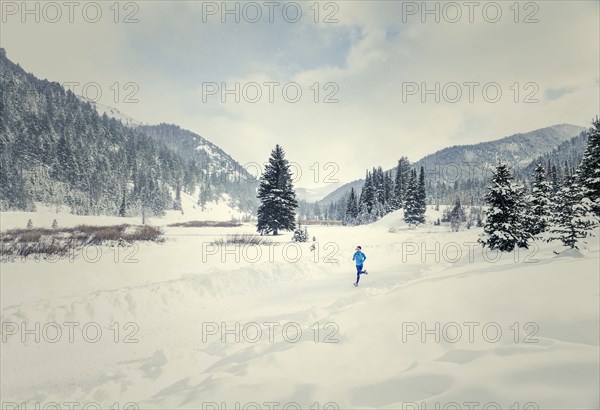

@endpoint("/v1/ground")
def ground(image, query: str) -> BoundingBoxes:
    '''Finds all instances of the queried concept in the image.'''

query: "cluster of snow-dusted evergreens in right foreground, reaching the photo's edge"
[480,119,600,252]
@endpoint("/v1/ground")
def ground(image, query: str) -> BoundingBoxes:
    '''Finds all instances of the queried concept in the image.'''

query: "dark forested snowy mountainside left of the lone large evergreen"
[0,49,257,215]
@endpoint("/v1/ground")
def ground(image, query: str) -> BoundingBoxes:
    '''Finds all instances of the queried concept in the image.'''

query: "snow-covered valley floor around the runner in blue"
[1,210,600,410]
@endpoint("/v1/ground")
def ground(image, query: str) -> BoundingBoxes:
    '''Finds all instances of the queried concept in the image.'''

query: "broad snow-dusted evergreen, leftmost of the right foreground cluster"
[479,163,531,252]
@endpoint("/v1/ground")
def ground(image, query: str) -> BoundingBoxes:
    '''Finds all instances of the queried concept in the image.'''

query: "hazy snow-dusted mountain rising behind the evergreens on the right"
[319,124,586,206]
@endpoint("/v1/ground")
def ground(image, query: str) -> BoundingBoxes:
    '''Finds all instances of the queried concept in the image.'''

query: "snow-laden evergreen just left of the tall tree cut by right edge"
[549,176,598,249]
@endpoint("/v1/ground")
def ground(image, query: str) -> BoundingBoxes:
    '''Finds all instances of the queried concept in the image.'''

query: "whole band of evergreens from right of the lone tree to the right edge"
[299,121,600,243]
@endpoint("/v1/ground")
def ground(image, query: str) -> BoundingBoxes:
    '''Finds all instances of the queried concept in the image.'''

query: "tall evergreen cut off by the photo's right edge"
[577,118,600,216]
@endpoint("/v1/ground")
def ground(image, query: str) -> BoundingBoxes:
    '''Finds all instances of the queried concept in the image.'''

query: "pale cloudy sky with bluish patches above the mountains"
[0,0,600,186]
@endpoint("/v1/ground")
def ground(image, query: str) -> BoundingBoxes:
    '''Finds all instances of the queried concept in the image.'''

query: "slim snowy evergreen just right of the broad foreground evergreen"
[527,164,552,236]
